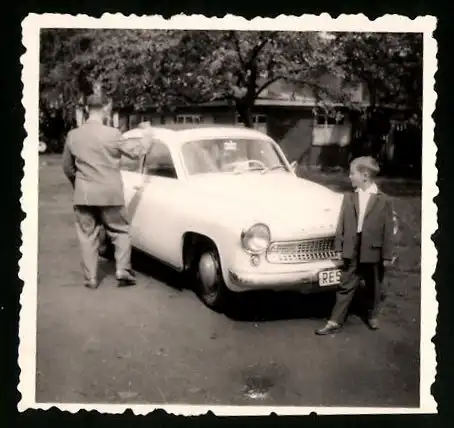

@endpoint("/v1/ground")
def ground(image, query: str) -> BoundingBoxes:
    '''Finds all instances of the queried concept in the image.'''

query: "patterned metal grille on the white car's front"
[266,237,338,263]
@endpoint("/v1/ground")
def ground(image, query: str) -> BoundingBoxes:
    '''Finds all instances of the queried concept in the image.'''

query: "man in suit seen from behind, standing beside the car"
[63,95,139,289]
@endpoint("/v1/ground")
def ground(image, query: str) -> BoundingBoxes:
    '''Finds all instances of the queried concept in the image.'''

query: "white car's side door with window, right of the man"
[128,142,181,267]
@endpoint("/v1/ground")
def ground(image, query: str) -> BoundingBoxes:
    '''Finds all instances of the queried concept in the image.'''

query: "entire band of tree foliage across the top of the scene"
[40,29,422,140]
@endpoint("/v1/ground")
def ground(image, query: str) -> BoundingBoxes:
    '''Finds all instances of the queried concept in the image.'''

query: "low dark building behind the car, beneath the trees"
[76,75,368,166]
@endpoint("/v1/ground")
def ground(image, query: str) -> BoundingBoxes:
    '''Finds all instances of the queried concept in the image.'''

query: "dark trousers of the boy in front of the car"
[330,233,384,324]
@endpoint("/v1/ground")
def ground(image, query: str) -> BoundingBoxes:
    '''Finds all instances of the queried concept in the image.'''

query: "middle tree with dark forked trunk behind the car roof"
[159,31,333,127]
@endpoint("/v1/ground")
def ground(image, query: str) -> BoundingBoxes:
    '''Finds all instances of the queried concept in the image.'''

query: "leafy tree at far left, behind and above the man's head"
[40,29,179,139]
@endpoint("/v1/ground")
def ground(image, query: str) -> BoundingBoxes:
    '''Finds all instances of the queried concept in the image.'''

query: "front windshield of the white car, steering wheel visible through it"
[182,138,288,175]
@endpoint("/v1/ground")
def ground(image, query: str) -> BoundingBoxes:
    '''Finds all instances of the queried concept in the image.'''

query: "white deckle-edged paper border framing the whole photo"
[18,13,438,416]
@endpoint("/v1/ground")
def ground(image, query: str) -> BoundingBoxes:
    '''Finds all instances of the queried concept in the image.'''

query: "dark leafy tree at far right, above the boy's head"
[320,33,423,166]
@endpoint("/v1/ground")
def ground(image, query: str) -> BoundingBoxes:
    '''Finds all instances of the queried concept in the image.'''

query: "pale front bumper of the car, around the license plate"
[227,260,342,293]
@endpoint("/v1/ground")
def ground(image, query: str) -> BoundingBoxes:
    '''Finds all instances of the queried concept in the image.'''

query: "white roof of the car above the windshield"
[123,124,270,144]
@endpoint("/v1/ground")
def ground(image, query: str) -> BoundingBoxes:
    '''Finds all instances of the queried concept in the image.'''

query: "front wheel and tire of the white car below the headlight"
[191,245,232,312]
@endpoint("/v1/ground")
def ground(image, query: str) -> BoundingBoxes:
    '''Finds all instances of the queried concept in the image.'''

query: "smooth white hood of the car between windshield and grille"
[186,172,342,239]
